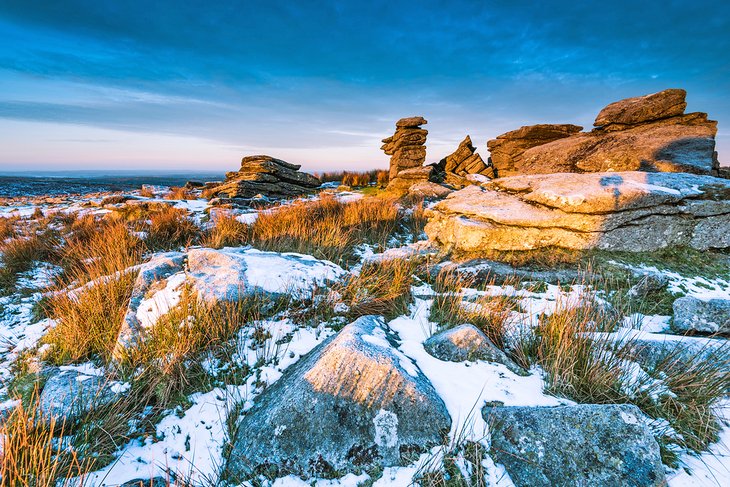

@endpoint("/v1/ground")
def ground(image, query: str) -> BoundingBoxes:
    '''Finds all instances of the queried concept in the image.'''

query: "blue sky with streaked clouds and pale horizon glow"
[0,0,730,171]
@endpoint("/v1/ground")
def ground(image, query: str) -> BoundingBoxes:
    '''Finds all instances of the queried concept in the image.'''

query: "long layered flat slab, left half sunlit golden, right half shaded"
[426,171,730,254]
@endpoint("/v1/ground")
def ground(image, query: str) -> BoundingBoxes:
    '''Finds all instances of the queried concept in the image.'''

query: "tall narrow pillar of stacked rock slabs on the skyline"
[381,117,433,189]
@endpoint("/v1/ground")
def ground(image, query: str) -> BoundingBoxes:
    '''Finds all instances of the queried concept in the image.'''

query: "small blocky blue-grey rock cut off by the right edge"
[672,298,730,333]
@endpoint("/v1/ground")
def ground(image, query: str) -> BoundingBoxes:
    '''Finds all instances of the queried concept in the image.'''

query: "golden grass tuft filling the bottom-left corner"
[0,395,89,487]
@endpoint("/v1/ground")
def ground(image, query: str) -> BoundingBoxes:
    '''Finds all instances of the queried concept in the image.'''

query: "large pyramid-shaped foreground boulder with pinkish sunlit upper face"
[228,316,451,477]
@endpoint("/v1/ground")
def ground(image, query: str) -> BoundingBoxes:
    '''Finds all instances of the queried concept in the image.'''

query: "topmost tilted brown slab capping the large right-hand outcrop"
[593,89,687,130]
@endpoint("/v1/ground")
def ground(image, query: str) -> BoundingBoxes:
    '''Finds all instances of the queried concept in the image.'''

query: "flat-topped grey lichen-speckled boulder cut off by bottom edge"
[482,404,666,487]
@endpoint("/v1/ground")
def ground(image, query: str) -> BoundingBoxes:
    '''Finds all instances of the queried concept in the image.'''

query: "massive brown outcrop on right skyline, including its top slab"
[487,89,719,177]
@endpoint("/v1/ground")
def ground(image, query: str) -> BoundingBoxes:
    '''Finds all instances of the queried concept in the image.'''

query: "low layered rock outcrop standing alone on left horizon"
[206,155,321,198]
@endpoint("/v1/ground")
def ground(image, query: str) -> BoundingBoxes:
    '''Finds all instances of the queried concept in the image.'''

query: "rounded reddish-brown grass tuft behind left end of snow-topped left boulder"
[145,206,201,250]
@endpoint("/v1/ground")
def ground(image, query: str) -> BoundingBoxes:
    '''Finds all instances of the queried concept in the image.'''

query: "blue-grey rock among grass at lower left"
[38,369,126,425]
